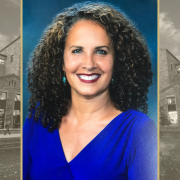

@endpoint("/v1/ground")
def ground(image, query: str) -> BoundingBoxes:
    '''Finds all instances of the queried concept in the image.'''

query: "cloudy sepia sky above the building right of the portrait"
[159,0,180,60]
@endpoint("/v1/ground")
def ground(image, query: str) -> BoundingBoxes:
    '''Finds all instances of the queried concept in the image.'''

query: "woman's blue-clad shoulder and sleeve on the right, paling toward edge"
[126,110,157,179]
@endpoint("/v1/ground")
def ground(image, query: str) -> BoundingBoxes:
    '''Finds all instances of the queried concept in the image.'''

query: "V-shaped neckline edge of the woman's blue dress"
[55,111,127,164]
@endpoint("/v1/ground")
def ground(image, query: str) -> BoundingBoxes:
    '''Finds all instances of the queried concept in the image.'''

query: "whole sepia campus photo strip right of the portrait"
[159,0,180,180]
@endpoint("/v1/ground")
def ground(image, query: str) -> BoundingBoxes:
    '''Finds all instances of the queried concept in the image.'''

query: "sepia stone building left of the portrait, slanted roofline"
[0,37,21,129]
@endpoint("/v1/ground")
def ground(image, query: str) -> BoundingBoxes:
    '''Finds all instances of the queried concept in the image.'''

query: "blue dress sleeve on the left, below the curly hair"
[23,111,34,180]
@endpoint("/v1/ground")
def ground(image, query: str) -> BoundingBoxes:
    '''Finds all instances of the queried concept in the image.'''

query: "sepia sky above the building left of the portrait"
[0,0,20,50]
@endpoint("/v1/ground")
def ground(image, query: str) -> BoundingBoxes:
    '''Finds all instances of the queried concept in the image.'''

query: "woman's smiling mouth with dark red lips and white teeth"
[77,74,101,83]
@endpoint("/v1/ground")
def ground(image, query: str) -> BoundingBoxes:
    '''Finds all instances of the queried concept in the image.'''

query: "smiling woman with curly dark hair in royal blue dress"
[23,3,157,180]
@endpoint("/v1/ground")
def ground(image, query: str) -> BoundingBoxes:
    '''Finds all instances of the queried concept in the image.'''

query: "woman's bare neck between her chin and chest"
[67,90,119,123]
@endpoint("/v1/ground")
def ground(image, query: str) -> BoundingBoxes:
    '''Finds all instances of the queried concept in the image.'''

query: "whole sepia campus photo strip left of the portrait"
[0,0,21,180]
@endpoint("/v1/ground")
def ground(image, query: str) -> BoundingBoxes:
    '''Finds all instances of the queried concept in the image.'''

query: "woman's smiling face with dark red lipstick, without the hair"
[63,20,114,97]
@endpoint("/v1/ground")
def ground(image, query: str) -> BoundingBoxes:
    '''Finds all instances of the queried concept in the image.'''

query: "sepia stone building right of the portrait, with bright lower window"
[159,49,180,129]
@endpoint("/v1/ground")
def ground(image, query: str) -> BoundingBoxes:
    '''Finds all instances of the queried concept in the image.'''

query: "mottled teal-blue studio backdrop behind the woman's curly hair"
[23,0,157,124]
